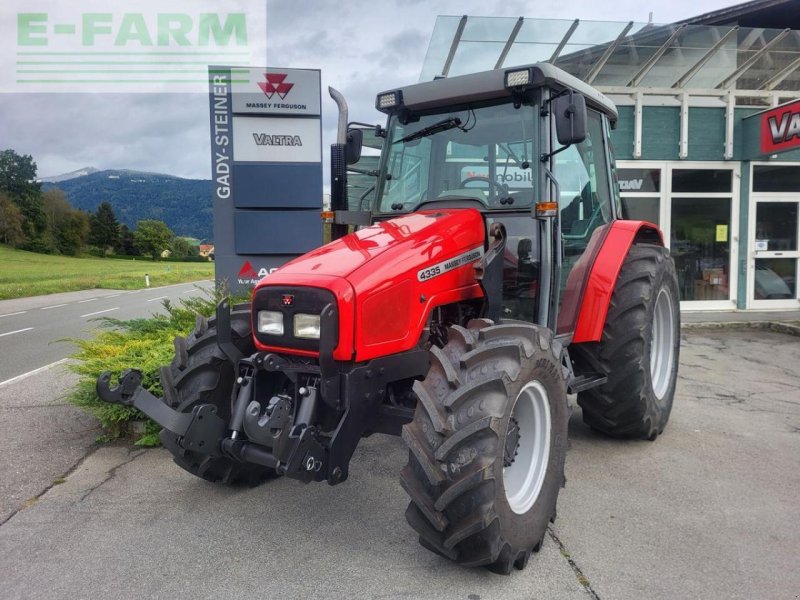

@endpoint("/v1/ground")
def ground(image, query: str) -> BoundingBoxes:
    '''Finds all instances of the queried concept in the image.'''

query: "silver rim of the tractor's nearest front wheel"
[503,381,550,515]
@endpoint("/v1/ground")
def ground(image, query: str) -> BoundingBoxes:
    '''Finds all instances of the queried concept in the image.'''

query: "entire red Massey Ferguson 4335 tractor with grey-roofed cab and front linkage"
[97,64,679,573]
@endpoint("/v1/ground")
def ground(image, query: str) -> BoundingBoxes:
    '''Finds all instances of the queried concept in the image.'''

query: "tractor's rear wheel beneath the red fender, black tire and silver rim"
[570,244,680,440]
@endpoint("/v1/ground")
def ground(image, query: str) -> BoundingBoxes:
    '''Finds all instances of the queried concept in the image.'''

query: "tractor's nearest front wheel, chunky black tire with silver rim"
[400,320,569,574]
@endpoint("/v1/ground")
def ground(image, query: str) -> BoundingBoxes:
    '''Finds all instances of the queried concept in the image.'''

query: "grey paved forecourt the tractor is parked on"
[0,330,800,600]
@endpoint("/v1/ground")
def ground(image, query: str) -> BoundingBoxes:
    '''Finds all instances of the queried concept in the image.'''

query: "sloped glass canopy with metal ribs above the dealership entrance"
[420,16,800,91]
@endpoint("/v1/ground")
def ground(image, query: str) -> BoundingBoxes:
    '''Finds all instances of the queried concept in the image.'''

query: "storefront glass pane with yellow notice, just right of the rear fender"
[670,198,731,300]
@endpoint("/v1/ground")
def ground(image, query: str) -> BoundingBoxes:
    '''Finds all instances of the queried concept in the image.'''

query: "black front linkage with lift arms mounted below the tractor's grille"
[96,301,430,485]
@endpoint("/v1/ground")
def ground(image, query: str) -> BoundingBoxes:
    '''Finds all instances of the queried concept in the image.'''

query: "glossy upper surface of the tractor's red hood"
[276,209,485,284]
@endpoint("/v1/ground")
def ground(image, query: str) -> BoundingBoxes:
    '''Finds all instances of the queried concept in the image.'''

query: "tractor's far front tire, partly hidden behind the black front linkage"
[160,305,276,486]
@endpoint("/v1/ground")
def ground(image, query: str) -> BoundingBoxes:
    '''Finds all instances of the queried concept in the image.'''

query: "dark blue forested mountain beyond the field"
[42,169,213,240]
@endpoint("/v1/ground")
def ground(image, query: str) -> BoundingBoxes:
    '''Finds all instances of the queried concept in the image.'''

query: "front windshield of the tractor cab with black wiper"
[377,103,535,213]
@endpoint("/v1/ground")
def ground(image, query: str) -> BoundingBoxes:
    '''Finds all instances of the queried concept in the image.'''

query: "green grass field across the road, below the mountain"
[0,245,214,300]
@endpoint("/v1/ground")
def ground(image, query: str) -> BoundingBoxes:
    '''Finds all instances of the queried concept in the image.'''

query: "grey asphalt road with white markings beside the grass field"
[0,281,212,383]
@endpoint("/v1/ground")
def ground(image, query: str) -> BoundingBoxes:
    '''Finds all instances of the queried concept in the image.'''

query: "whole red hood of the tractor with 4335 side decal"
[254,208,486,361]
